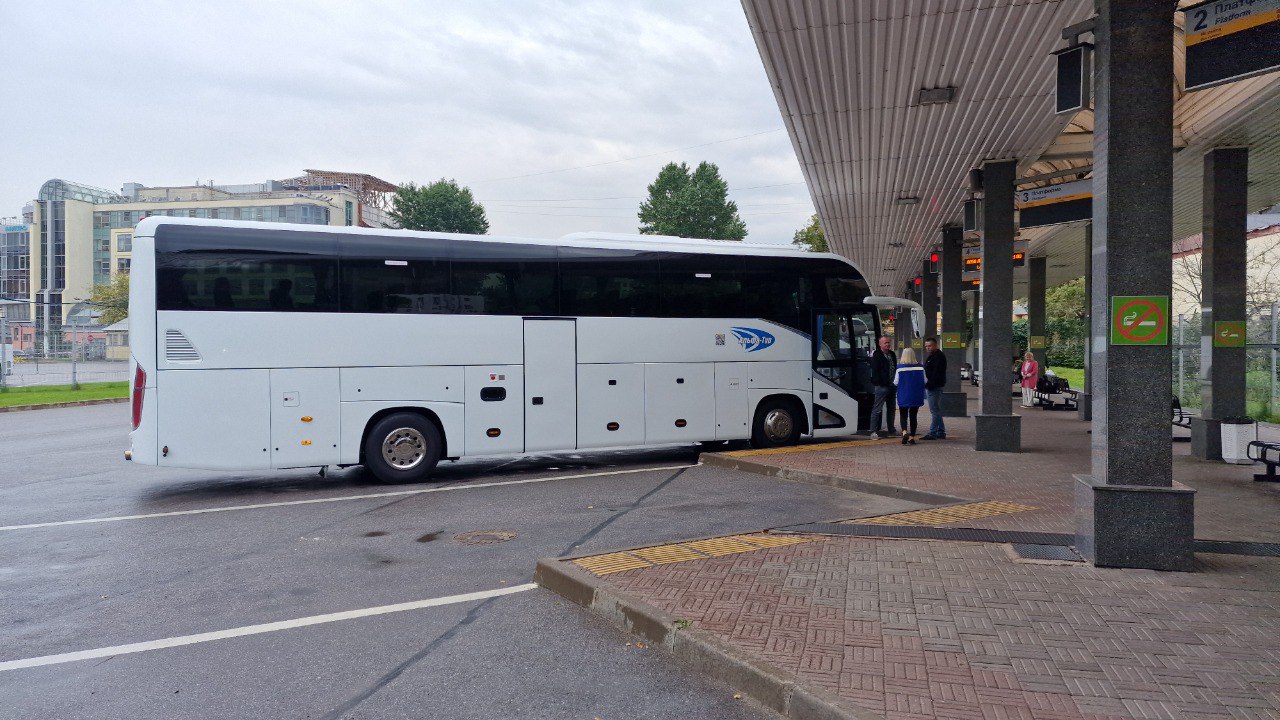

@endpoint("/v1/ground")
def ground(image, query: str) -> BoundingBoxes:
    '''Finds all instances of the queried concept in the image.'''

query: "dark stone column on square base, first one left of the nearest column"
[974,160,1023,452]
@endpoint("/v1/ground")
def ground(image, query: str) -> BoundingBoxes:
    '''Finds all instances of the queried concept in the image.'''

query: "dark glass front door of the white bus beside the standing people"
[813,310,876,432]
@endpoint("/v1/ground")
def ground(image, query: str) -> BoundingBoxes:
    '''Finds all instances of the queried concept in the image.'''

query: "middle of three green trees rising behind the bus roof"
[639,163,746,240]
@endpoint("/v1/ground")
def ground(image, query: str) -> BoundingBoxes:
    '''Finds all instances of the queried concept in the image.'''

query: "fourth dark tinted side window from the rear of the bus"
[559,247,659,318]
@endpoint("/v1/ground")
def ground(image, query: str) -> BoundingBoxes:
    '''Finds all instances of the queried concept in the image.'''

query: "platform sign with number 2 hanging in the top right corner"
[1181,0,1280,90]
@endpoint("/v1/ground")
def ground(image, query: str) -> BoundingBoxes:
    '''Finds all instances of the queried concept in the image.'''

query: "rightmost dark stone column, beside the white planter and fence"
[1192,147,1249,460]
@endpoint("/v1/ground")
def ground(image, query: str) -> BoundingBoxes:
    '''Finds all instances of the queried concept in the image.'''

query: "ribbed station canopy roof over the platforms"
[742,0,1280,295]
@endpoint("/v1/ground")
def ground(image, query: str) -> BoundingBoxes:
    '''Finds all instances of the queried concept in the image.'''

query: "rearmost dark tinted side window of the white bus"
[156,225,338,313]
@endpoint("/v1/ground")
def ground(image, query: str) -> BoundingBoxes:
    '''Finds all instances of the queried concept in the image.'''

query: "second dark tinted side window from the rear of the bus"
[342,237,462,313]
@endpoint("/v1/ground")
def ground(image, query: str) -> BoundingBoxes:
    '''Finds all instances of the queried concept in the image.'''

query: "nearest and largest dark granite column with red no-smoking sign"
[1075,0,1194,570]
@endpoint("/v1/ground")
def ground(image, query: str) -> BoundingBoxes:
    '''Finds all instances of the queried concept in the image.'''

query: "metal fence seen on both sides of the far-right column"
[1172,298,1280,420]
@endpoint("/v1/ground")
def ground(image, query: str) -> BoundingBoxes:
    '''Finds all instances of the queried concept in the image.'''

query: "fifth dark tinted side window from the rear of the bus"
[660,254,745,318]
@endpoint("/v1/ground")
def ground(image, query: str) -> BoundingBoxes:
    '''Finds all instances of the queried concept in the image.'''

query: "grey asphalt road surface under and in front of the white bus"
[0,405,914,720]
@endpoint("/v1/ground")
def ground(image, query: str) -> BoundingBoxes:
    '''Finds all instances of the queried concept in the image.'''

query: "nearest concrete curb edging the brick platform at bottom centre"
[534,553,883,720]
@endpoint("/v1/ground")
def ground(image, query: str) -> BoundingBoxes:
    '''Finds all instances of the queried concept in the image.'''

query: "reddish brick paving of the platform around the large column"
[583,384,1280,720]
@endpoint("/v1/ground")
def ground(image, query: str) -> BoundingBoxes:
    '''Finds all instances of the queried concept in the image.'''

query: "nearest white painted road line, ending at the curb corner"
[0,583,538,673]
